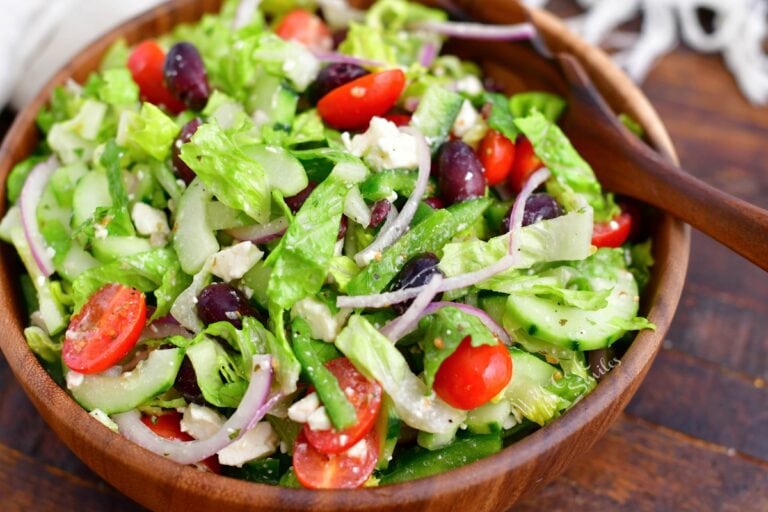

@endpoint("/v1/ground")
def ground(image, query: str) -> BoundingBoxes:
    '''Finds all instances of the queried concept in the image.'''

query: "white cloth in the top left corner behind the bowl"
[0,0,162,108]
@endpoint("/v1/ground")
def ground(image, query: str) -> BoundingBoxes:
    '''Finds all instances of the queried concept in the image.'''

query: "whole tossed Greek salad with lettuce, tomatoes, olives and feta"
[0,0,653,489]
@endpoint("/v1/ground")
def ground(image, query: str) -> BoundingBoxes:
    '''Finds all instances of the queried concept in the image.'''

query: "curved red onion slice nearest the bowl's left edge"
[19,156,59,277]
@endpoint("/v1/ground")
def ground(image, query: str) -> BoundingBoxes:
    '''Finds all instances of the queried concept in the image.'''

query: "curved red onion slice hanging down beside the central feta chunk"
[355,127,432,266]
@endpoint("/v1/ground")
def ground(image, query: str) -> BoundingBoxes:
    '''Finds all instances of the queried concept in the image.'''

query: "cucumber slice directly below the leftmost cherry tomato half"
[69,348,184,414]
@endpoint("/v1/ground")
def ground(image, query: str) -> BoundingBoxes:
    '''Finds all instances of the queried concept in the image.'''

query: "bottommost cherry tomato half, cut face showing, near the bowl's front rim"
[293,430,379,489]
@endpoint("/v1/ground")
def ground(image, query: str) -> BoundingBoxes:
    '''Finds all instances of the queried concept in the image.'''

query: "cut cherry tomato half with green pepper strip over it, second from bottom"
[304,357,381,454]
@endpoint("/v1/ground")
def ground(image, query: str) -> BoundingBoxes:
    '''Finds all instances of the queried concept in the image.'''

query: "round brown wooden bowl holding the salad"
[0,0,689,512]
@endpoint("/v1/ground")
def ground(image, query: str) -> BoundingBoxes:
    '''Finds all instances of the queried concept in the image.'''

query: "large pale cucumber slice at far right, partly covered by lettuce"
[504,270,639,350]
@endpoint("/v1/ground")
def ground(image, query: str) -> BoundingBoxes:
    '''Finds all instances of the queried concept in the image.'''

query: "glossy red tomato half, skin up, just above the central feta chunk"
[317,69,405,130]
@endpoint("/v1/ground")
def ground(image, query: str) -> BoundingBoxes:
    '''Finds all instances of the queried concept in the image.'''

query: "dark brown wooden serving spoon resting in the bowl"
[555,53,768,270]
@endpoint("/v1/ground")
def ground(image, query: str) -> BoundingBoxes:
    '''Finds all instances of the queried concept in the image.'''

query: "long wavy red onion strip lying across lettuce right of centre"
[336,168,551,308]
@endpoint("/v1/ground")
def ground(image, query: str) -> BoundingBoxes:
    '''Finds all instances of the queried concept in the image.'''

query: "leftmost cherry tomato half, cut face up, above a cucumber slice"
[61,284,147,373]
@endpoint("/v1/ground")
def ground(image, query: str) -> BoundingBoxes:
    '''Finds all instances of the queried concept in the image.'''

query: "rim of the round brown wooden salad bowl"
[0,0,690,510]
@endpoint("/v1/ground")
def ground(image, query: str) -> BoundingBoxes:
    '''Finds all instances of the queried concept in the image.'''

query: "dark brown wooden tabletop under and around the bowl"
[0,2,768,512]
